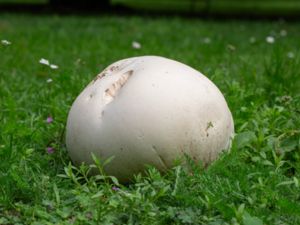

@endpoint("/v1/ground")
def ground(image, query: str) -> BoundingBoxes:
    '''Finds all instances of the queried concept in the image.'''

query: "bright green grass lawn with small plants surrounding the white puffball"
[0,14,300,225]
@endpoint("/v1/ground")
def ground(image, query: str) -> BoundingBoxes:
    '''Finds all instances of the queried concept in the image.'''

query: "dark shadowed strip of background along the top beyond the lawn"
[0,0,300,19]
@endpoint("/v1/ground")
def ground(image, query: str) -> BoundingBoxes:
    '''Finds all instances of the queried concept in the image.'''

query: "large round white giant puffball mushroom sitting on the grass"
[66,56,234,182]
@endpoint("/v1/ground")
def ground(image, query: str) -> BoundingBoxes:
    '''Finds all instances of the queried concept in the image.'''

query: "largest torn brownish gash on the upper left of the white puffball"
[104,70,133,104]
